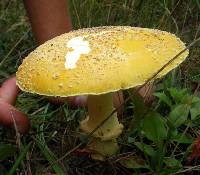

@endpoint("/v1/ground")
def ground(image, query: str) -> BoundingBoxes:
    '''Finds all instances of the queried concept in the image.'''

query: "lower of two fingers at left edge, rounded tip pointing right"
[0,99,30,133]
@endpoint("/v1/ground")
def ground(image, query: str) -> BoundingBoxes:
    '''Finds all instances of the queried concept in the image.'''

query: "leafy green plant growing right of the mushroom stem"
[123,85,200,174]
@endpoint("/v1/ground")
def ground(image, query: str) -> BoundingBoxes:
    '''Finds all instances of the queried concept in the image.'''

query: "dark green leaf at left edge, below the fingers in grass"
[0,144,16,160]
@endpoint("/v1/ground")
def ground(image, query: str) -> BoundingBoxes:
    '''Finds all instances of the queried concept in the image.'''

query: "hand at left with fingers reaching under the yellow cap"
[0,77,87,133]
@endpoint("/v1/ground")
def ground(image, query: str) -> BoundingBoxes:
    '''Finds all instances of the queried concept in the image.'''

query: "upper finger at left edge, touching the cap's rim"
[0,77,19,105]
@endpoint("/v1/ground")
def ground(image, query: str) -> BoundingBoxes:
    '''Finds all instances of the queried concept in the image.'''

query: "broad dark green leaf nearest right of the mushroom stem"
[143,111,167,142]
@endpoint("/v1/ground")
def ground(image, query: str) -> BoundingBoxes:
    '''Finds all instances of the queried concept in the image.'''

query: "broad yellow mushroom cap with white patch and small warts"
[16,26,188,97]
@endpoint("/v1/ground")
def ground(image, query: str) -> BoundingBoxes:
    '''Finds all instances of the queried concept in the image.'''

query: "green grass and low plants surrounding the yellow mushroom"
[0,0,200,175]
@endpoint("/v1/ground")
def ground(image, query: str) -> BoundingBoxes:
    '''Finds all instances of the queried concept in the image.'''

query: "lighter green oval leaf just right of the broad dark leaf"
[169,104,190,127]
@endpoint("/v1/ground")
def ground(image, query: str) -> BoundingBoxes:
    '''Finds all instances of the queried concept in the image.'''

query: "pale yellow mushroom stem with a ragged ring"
[80,93,123,159]
